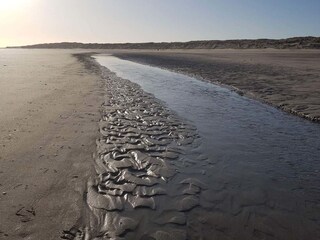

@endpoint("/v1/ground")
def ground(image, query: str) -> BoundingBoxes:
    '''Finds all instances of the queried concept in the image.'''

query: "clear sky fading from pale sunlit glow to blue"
[0,0,320,47]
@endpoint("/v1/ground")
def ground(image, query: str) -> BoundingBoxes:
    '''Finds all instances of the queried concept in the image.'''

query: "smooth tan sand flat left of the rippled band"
[0,50,103,239]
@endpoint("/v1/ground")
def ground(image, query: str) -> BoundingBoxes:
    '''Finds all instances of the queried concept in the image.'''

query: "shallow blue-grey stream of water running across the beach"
[95,55,320,239]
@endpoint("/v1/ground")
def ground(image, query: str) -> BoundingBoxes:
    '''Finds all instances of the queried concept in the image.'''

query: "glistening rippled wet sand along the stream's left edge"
[63,63,206,240]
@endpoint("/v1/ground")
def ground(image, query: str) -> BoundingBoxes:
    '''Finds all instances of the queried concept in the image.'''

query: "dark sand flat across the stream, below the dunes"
[114,49,320,121]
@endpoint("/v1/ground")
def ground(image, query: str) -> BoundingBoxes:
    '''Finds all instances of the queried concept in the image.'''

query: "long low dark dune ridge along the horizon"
[8,37,320,49]
